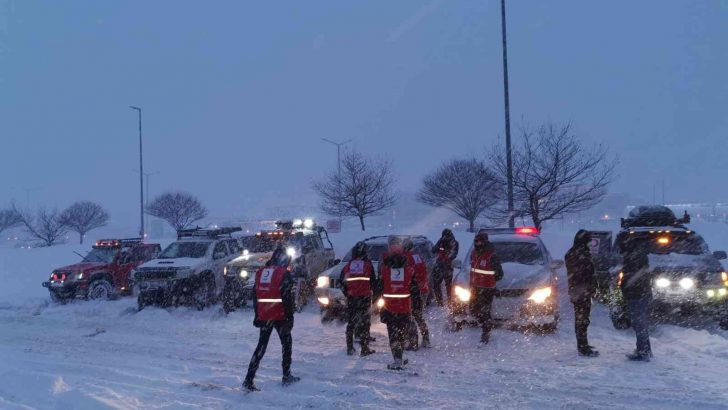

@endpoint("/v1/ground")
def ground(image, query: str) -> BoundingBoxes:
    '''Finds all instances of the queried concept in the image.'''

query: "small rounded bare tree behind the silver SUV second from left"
[146,192,207,231]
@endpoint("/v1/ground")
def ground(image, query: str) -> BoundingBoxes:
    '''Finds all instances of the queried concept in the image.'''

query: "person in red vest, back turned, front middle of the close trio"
[379,236,417,370]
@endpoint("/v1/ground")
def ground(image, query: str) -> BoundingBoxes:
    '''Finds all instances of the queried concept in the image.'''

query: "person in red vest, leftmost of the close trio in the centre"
[339,242,377,356]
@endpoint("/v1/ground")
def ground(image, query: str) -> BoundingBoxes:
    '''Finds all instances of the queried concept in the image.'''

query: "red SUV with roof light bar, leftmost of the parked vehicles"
[43,239,161,302]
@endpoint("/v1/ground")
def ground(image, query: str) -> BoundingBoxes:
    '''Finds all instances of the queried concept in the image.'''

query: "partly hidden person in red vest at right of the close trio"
[403,238,430,351]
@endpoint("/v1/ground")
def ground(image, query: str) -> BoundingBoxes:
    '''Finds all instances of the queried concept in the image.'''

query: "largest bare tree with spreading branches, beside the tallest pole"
[491,123,617,229]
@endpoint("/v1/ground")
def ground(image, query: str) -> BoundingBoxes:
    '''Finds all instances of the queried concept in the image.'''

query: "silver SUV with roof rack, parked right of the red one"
[134,228,241,310]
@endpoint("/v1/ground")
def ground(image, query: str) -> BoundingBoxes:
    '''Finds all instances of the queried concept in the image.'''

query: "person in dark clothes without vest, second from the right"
[564,229,599,357]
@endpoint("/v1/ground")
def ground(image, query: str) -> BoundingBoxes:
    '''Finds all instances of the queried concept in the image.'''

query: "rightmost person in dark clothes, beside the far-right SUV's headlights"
[620,237,652,362]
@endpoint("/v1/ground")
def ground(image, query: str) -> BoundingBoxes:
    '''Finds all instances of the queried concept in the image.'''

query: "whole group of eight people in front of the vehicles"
[243,229,652,391]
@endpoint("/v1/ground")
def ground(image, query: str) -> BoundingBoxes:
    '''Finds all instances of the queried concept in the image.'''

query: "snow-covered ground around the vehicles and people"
[0,225,728,409]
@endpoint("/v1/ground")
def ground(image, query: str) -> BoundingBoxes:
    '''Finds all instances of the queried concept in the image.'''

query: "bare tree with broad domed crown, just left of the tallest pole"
[417,158,502,232]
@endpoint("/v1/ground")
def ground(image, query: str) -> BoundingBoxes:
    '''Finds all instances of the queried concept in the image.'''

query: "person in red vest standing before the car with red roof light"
[470,232,503,345]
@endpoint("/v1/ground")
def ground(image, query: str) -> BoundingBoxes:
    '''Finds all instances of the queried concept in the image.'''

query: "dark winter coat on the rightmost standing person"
[621,238,652,299]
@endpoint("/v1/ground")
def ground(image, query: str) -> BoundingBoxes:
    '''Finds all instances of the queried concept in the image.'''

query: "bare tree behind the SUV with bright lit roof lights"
[313,151,397,231]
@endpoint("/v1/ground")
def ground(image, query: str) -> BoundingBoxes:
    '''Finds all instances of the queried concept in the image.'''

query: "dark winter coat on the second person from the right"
[564,235,596,302]
